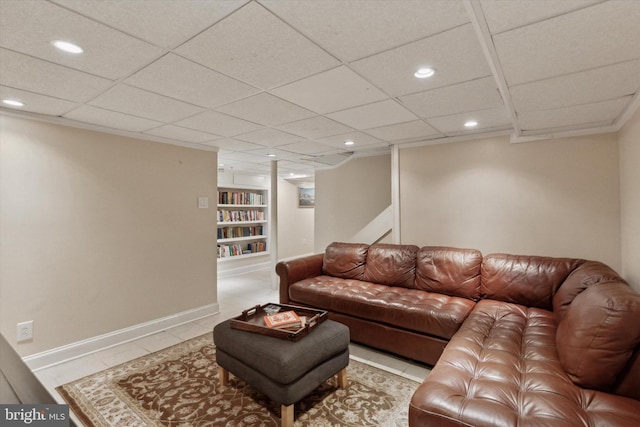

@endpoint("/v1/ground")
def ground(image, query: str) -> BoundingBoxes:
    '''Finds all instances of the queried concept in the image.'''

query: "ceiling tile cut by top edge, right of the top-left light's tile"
[53,0,247,48]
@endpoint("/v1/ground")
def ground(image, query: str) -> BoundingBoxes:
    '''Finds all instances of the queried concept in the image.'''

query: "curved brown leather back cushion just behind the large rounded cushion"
[553,261,624,323]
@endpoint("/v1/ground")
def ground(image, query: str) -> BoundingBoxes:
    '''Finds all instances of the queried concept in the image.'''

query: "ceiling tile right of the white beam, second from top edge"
[493,1,640,86]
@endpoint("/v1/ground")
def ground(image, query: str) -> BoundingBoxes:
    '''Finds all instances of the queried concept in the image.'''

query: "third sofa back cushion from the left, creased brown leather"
[416,246,482,301]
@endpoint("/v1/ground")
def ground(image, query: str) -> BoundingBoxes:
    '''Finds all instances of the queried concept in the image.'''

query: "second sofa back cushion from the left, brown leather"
[364,243,419,288]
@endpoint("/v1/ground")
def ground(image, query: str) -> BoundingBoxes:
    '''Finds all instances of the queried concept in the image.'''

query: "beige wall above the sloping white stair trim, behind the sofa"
[314,154,391,252]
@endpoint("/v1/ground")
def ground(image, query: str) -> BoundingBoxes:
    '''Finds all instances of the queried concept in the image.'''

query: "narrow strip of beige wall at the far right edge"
[619,110,640,291]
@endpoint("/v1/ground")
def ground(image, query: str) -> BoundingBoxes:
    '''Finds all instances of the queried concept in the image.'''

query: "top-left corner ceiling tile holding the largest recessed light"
[0,1,162,79]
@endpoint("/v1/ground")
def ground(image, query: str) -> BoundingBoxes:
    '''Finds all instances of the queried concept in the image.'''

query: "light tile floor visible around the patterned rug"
[35,270,429,426]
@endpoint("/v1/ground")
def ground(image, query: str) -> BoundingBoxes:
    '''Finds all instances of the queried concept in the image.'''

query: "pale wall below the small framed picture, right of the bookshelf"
[278,179,315,260]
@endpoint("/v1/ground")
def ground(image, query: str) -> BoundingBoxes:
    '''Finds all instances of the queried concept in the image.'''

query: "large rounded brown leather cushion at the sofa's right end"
[556,282,640,391]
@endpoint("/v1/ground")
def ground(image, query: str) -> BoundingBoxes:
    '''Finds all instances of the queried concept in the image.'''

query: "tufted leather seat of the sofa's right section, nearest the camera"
[409,300,640,427]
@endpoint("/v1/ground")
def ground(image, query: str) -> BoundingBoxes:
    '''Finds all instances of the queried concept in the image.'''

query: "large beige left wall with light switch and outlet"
[0,116,217,355]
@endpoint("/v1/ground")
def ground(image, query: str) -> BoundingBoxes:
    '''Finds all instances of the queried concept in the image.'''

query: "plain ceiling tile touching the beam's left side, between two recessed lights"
[400,77,502,118]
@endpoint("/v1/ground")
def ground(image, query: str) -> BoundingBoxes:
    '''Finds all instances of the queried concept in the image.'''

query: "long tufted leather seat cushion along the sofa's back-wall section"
[289,276,475,340]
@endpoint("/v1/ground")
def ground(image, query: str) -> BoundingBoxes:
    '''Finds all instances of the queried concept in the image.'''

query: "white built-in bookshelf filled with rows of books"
[217,187,269,261]
